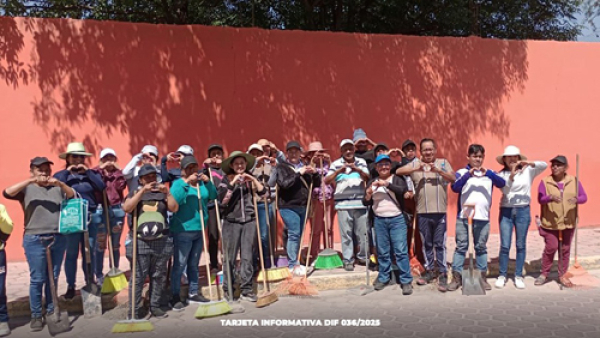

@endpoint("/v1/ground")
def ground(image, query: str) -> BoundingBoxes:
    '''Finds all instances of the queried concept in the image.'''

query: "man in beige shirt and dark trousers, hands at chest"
[396,138,456,292]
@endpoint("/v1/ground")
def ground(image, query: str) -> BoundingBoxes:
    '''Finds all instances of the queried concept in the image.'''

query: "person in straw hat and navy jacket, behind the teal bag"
[54,142,106,299]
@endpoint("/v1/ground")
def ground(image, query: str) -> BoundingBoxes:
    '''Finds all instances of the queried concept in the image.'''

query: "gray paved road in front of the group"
[5,271,600,338]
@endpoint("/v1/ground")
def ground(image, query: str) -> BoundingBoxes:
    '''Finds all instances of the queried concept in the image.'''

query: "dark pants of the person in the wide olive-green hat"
[222,220,258,293]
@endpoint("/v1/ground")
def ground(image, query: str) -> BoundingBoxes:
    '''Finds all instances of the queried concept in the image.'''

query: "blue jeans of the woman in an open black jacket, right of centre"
[373,215,412,284]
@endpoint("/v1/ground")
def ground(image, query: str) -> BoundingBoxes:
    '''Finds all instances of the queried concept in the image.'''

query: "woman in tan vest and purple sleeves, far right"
[535,155,587,288]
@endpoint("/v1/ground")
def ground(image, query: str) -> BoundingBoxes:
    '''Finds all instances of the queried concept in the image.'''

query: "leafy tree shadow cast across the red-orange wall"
[0,18,527,167]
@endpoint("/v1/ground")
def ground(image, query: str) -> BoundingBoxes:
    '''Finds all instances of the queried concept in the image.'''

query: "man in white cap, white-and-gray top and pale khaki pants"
[325,139,369,271]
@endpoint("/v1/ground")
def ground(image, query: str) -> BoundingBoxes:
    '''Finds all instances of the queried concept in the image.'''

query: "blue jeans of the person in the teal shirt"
[90,205,125,278]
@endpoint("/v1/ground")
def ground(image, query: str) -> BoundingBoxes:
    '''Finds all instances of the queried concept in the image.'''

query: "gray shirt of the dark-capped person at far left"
[4,184,66,235]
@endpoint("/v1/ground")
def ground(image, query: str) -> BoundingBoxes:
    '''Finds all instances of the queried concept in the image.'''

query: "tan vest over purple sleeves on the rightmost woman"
[541,175,577,230]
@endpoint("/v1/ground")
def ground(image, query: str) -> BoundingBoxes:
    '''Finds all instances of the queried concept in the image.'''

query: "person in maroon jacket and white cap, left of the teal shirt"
[94,148,127,285]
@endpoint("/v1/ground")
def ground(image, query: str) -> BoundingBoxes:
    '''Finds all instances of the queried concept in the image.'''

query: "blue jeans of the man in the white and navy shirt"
[452,218,490,273]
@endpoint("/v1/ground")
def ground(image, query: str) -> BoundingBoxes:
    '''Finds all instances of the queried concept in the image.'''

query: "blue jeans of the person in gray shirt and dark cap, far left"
[23,234,67,318]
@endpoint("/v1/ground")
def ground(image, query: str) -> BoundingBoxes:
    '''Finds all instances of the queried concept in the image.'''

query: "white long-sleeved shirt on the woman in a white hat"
[498,161,548,208]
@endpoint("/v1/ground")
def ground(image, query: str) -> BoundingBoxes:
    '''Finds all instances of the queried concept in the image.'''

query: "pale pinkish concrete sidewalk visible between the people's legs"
[6,227,600,316]
